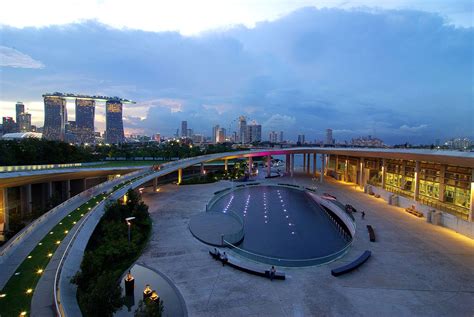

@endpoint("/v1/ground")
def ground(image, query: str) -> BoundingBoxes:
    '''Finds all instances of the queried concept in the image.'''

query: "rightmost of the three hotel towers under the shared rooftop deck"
[105,99,125,144]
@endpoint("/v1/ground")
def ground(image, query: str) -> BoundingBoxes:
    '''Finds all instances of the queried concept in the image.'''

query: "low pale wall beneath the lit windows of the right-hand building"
[367,185,474,239]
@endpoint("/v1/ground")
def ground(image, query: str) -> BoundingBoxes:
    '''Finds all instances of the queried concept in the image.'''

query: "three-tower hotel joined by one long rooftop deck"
[43,92,135,143]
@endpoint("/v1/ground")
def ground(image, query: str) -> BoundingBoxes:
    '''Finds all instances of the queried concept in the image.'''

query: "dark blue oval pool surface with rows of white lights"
[212,186,347,259]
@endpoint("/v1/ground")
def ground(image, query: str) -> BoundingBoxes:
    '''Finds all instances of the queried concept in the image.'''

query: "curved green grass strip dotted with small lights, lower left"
[0,175,146,316]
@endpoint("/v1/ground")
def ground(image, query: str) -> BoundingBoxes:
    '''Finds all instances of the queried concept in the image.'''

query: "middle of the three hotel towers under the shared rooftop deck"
[75,98,95,143]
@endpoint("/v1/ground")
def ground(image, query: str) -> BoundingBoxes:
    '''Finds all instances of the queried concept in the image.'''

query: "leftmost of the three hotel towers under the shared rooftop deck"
[43,95,67,141]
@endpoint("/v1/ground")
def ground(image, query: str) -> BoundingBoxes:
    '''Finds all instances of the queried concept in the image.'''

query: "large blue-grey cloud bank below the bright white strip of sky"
[1,8,474,142]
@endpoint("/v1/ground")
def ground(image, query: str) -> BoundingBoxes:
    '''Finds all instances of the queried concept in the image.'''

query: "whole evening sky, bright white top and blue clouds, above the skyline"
[0,0,474,144]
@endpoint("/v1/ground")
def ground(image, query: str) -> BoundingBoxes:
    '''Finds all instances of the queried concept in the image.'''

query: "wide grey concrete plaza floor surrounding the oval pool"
[138,176,474,316]
